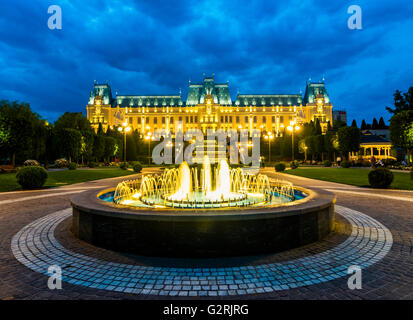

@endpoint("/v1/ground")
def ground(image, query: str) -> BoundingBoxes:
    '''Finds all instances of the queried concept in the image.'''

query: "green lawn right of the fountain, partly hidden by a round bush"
[285,167,413,190]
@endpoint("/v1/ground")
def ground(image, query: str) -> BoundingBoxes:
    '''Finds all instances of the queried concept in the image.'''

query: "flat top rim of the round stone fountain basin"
[71,186,336,221]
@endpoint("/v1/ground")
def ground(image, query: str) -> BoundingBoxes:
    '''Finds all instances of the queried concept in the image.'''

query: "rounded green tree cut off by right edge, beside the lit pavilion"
[390,110,413,162]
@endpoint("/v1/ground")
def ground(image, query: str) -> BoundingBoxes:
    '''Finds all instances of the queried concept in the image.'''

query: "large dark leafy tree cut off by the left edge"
[0,101,46,166]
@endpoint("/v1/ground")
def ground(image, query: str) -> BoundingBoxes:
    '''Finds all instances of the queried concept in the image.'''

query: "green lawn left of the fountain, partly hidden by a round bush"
[0,168,135,192]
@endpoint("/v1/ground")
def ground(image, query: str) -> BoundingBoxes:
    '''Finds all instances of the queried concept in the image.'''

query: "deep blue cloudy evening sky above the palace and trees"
[0,0,413,124]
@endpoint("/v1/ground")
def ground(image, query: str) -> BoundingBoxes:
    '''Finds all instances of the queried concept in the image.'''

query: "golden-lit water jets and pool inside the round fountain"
[100,157,306,209]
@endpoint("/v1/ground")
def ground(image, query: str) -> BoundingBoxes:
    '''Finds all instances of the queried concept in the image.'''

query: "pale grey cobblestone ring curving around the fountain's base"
[11,206,393,296]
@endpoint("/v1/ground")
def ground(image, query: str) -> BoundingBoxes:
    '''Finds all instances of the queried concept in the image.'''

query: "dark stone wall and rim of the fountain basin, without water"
[71,187,335,257]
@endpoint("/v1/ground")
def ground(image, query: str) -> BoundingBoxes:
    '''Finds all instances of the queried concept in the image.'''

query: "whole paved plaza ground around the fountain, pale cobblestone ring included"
[0,171,413,299]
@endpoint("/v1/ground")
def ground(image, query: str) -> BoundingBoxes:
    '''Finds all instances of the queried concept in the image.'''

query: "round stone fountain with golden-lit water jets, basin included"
[72,158,335,257]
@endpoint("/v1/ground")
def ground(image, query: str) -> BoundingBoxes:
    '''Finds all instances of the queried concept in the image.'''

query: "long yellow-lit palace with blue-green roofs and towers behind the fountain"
[87,77,333,136]
